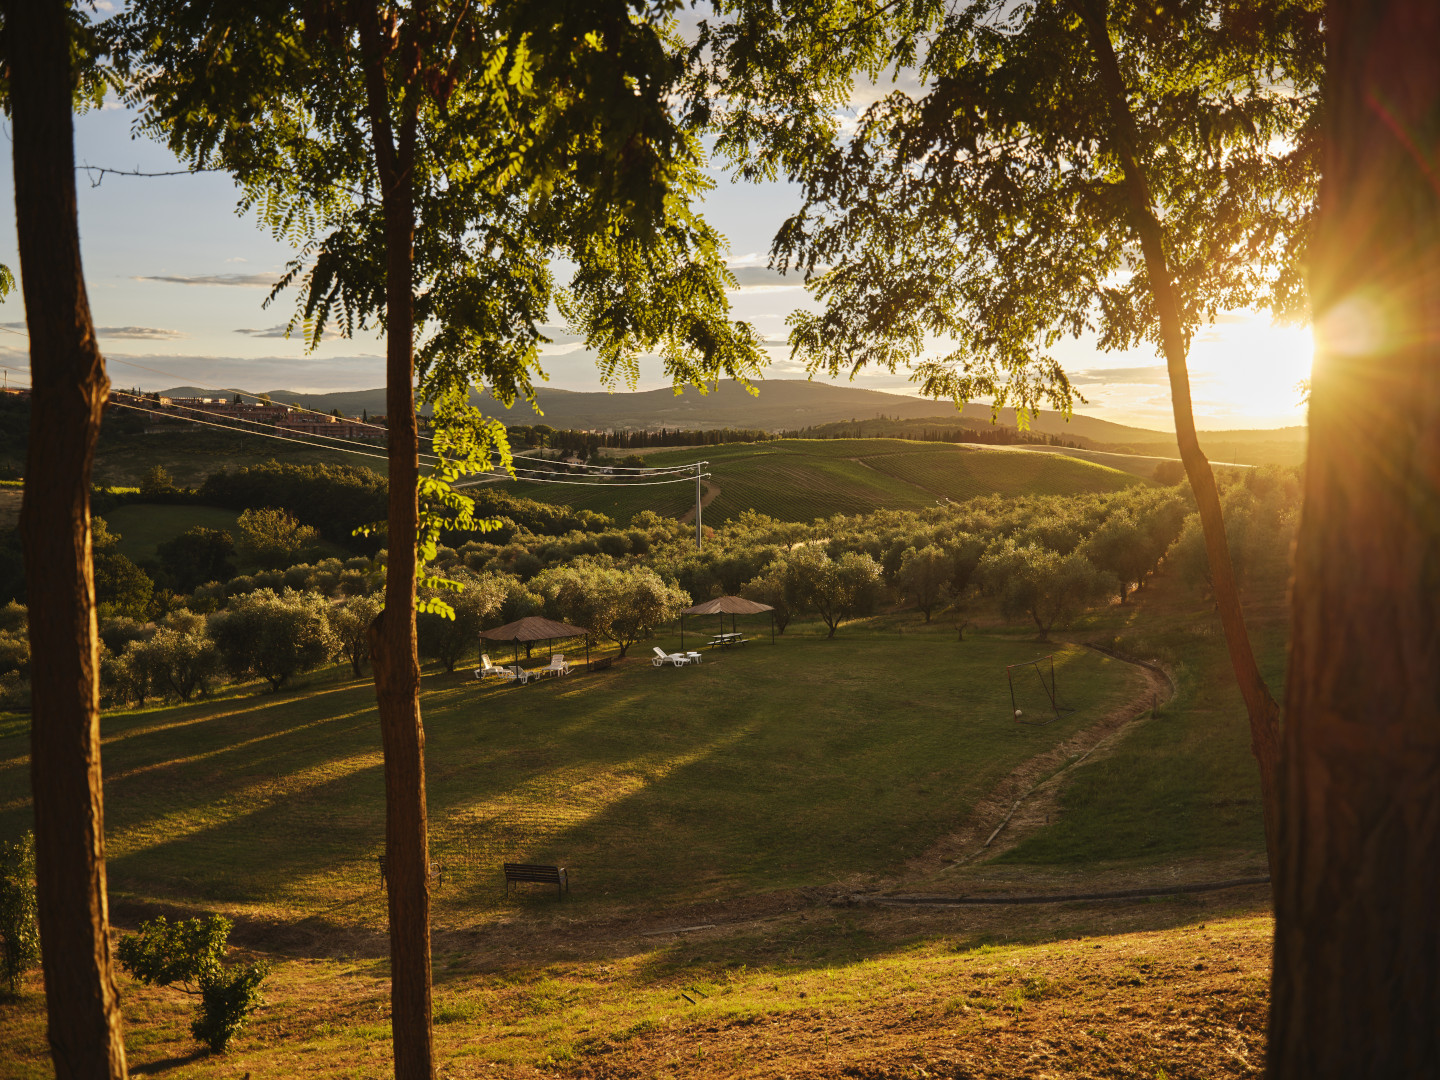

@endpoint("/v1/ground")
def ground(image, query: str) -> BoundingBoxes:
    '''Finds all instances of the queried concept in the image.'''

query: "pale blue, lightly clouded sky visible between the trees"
[0,90,1310,431]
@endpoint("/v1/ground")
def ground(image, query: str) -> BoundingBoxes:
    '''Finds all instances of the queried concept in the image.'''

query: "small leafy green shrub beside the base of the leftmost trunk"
[117,916,269,1054]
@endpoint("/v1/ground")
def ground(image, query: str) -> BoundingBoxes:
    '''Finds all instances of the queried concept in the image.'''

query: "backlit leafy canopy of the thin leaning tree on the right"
[696,0,1322,410]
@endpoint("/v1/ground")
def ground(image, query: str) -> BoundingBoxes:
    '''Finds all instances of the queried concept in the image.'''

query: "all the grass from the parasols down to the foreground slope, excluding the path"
[0,577,1284,1080]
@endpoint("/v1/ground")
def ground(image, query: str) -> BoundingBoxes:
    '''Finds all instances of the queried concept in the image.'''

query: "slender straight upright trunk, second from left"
[361,12,435,1080]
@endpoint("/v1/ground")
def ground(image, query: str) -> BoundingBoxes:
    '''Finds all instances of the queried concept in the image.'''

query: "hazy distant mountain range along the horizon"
[164,379,1305,452]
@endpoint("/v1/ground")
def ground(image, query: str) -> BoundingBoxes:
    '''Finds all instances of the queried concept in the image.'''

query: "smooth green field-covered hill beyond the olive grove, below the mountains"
[507,439,1139,524]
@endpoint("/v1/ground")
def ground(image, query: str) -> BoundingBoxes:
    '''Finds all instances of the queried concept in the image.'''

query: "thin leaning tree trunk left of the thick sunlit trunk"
[1076,0,1280,880]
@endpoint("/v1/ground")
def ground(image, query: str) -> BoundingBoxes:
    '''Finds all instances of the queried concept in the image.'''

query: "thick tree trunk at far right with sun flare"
[1269,0,1440,1077]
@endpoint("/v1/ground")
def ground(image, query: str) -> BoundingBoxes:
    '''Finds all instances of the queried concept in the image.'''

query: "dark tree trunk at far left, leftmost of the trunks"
[6,0,125,1080]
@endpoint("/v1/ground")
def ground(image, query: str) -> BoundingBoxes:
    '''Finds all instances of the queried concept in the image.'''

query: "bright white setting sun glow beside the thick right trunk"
[1189,312,1315,428]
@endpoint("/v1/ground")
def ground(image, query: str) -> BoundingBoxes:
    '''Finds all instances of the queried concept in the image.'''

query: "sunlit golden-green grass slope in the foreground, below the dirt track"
[0,897,1272,1080]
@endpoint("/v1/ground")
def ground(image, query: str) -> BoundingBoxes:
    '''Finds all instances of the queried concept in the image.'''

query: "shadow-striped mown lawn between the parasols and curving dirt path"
[0,626,1136,924]
